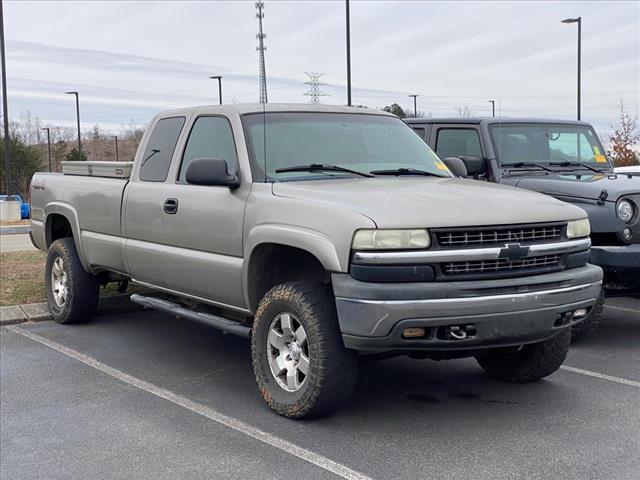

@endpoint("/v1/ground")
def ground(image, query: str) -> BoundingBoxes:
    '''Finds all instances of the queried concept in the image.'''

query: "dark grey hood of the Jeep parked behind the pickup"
[500,174,640,202]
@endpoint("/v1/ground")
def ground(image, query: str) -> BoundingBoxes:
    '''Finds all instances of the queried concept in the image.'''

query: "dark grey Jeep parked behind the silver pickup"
[407,118,640,339]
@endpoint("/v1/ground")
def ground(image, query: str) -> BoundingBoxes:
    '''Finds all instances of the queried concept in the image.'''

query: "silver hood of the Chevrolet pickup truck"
[273,177,586,228]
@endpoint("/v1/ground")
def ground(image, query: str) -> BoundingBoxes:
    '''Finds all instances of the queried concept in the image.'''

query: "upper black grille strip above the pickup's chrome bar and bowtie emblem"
[435,224,564,247]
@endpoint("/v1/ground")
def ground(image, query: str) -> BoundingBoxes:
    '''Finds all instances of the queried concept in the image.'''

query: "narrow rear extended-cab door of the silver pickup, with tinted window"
[122,116,186,287]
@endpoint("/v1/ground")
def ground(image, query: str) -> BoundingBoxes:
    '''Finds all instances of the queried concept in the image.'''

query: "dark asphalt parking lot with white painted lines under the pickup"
[0,298,640,480]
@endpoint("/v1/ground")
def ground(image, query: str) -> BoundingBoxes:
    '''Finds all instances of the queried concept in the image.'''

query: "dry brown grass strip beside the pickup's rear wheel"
[0,250,149,307]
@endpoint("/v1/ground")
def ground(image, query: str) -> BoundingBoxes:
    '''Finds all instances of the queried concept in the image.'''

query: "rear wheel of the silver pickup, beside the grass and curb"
[44,238,100,323]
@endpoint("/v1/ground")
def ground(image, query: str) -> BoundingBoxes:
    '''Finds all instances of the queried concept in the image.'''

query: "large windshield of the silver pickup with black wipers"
[243,112,451,181]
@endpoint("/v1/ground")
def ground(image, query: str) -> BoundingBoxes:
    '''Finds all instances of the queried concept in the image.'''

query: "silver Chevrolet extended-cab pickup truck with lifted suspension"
[31,105,602,418]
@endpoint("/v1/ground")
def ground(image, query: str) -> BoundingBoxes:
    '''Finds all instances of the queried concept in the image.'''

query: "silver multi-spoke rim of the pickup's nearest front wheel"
[267,313,309,392]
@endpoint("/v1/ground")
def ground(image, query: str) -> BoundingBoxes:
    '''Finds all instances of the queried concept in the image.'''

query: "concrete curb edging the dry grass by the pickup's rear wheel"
[0,295,143,326]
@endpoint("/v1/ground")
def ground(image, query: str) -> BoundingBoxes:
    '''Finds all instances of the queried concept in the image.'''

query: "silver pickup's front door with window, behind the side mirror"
[160,115,251,308]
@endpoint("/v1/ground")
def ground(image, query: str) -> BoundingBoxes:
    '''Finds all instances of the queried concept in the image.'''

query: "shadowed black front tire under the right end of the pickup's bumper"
[476,329,571,383]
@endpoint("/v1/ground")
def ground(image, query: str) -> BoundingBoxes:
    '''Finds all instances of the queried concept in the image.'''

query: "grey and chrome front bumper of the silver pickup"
[332,265,602,351]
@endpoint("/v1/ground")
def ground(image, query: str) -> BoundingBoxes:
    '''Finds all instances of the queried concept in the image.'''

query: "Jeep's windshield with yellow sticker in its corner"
[489,123,610,168]
